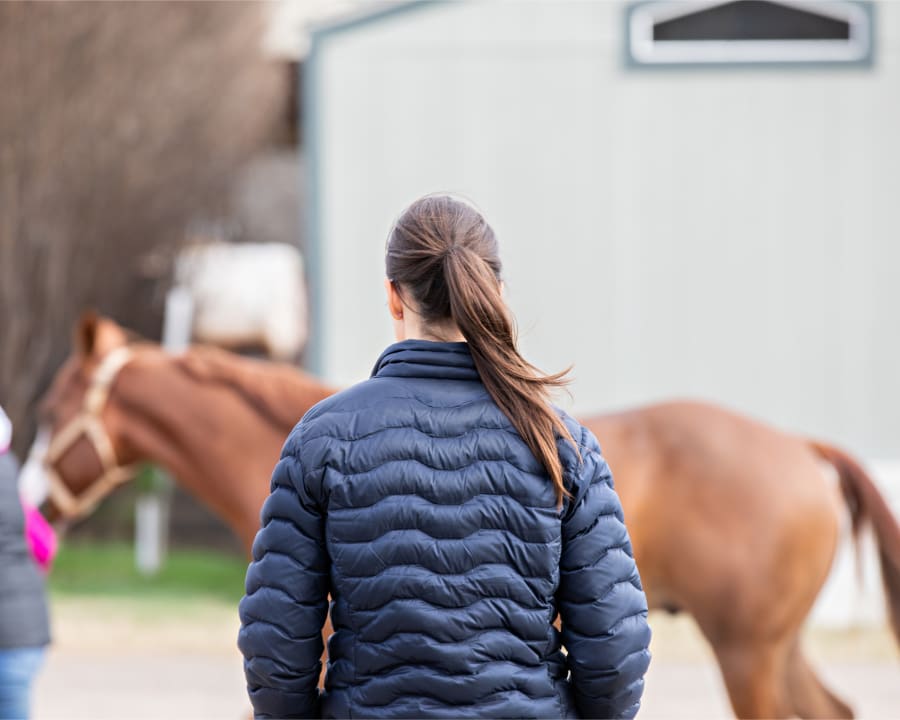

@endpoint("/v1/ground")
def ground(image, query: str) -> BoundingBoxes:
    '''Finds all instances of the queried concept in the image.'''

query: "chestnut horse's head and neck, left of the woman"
[23,315,334,544]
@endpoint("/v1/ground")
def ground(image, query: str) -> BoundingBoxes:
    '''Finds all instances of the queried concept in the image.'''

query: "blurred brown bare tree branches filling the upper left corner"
[0,2,285,453]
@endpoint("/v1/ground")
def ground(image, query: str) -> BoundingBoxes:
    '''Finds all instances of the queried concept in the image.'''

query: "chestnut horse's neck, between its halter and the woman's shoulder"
[116,359,310,549]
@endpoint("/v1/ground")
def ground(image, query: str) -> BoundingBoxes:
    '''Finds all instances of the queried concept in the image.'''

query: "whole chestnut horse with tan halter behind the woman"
[31,317,900,718]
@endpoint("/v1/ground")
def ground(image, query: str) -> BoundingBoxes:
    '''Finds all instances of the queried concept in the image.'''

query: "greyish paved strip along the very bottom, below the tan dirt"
[35,652,900,720]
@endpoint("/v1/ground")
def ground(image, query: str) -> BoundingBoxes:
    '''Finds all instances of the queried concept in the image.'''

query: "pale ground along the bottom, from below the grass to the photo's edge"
[35,599,900,720]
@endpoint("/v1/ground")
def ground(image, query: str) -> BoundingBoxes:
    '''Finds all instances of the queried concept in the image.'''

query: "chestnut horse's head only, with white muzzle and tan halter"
[23,313,141,520]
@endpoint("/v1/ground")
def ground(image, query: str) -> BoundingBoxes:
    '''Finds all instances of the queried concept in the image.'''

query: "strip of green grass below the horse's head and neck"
[49,543,247,604]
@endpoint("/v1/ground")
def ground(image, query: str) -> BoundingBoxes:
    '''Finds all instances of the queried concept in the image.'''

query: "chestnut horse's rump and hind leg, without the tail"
[586,403,884,718]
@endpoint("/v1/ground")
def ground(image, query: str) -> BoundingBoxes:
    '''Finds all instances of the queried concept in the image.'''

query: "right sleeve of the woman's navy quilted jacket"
[557,429,650,718]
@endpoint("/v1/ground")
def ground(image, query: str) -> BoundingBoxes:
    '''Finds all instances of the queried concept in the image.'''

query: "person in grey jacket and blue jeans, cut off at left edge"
[0,408,50,720]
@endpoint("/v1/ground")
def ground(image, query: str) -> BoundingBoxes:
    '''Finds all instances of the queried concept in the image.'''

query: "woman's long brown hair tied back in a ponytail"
[385,195,577,504]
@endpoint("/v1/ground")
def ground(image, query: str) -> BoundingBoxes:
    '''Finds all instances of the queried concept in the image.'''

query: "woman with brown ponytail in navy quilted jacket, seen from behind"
[239,196,650,718]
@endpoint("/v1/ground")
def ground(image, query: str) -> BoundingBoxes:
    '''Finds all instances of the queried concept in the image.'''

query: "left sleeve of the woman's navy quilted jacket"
[238,426,329,718]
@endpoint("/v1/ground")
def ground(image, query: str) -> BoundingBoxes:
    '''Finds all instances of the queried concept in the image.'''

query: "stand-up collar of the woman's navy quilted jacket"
[372,340,479,380]
